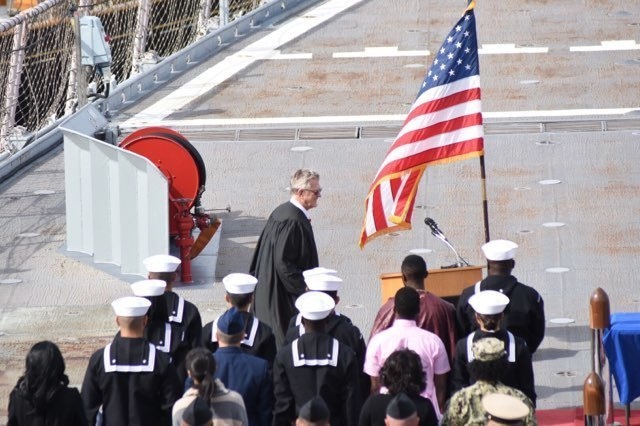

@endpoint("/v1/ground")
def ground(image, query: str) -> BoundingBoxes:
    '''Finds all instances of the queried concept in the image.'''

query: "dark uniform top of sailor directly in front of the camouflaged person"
[451,330,536,407]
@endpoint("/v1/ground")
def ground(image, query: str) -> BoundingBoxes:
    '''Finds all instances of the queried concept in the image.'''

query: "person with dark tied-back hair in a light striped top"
[172,348,249,426]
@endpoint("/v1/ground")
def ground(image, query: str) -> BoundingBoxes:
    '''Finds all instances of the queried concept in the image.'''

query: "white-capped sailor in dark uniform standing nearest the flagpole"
[456,240,545,354]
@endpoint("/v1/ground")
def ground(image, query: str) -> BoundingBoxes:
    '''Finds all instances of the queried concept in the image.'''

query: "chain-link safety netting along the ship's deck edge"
[0,0,266,153]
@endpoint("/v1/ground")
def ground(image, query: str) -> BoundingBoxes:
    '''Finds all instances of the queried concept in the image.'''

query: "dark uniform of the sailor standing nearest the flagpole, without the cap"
[456,275,545,354]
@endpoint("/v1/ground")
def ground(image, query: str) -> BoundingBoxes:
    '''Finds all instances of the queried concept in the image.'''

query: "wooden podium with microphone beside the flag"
[380,266,482,303]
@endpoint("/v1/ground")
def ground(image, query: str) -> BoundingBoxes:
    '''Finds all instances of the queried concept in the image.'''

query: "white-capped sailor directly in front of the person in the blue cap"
[202,273,276,367]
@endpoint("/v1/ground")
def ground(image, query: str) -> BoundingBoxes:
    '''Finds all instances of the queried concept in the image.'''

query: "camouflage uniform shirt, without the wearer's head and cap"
[441,381,538,426]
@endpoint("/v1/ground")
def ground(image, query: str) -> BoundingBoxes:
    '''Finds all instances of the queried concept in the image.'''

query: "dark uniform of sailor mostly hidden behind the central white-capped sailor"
[285,312,371,398]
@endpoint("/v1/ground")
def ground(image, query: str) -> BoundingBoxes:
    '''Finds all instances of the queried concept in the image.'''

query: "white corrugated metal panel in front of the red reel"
[62,129,169,276]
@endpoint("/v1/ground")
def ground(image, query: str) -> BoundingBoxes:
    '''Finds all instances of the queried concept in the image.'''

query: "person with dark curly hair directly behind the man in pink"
[359,349,438,426]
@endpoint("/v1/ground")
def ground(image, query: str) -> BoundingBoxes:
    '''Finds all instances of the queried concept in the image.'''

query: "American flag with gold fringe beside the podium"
[360,2,484,247]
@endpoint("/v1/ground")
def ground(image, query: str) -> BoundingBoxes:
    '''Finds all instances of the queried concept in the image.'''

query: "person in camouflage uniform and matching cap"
[441,337,538,426]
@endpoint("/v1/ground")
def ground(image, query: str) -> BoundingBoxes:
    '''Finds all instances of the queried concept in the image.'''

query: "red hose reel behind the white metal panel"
[120,127,220,283]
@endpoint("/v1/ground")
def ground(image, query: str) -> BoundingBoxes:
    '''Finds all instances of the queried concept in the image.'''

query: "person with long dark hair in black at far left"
[7,341,88,426]
